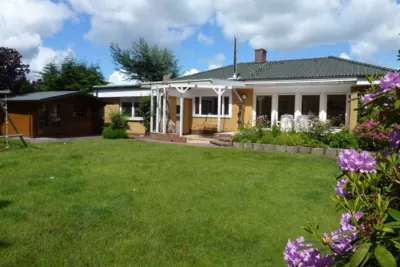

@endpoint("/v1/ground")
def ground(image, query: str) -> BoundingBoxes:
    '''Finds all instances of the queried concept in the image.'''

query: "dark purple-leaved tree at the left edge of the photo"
[0,47,29,92]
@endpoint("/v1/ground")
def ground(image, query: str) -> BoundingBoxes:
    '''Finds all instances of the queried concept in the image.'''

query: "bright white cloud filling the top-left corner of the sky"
[0,0,73,58]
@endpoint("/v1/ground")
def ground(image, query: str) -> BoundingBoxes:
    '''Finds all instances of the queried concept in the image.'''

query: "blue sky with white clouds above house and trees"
[0,0,400,83]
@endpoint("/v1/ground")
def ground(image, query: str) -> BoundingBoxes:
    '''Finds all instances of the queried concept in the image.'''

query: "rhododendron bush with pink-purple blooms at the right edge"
[284,73,400,267]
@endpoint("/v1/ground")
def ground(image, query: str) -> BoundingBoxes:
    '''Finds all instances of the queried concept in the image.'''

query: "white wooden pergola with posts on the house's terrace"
[142,79,246,136]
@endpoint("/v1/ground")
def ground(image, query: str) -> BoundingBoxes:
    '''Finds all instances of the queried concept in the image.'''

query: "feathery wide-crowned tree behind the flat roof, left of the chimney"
[110,38,180,82]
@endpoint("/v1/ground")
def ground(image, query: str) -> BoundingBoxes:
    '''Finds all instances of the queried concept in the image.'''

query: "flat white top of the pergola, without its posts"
[141,79,246,89]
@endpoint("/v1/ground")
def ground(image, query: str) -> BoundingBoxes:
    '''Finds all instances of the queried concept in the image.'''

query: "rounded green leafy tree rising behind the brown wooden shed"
[40,57,107,92]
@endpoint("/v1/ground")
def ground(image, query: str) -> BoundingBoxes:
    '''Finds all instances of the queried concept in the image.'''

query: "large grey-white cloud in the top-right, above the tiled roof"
[215,0,400,61]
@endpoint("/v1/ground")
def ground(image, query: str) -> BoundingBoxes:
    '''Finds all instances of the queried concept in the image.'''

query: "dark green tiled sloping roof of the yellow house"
[177,56,396,80]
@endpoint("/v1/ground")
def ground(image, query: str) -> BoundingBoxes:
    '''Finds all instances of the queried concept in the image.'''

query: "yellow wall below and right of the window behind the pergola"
[191,89,253,132]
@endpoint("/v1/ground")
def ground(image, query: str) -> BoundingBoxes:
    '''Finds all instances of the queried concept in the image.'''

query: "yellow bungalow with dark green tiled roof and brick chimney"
[95,49,395,136]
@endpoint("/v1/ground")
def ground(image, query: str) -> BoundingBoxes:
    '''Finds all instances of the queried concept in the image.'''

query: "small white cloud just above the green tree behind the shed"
[23,46,75,80]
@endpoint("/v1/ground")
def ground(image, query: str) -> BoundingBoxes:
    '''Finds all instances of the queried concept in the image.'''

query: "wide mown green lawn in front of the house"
[0,139,338,267]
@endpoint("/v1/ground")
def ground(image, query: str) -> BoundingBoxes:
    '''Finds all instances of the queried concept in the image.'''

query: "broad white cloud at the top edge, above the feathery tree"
[68,0,213,46]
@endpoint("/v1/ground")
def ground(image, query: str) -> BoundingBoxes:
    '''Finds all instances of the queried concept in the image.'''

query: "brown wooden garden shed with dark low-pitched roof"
[0,91,106,137]
